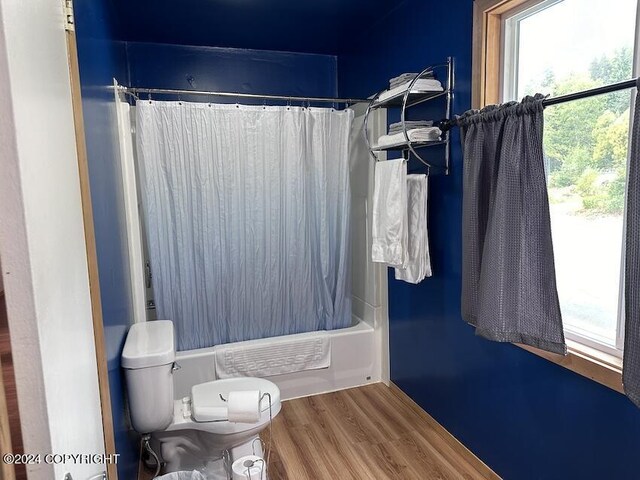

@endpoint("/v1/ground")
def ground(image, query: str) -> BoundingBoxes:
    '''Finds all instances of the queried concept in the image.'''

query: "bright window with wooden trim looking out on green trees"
[474,0,638,368]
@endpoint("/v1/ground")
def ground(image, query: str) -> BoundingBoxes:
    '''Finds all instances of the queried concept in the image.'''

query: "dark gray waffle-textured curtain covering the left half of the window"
[457,95,566,354]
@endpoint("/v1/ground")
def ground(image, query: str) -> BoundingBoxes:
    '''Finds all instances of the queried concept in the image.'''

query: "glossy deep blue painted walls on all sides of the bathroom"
[76,0,640,480]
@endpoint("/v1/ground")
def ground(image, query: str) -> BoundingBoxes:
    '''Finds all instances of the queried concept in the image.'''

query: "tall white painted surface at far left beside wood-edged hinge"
[0,0,104,480]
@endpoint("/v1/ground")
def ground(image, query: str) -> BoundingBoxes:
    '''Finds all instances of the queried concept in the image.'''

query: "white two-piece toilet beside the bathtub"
[121,320,280,480]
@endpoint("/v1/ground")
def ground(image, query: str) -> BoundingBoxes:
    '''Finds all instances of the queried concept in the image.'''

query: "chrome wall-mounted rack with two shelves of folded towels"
[364,57,454,174]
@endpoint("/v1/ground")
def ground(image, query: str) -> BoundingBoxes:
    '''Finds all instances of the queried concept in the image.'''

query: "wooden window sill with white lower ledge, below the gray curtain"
[515,340,624,393]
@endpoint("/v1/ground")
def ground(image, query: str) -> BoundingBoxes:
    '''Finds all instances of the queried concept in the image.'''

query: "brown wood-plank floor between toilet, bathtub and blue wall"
[139,383,500,480]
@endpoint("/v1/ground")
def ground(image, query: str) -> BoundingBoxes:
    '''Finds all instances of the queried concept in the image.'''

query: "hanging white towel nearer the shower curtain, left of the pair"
[371,159,408,267]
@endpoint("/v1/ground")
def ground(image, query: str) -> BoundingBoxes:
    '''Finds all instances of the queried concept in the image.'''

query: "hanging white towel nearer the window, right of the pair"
[396,175,431,283]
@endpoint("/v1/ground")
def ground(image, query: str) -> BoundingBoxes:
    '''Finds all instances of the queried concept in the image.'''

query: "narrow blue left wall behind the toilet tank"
[74,0,139,480]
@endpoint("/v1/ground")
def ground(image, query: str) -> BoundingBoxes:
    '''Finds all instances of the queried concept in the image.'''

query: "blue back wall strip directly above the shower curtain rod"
[122,42,338,99]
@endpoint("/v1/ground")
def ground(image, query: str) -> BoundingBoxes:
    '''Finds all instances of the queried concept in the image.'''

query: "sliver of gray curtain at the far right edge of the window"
[622,86,640,407]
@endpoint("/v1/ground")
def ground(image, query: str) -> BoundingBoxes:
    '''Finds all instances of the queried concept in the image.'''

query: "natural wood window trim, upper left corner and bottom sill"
[471,0,624,393]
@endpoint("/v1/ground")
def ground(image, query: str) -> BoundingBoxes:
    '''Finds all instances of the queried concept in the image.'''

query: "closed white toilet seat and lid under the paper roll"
[164,377,280,435]
